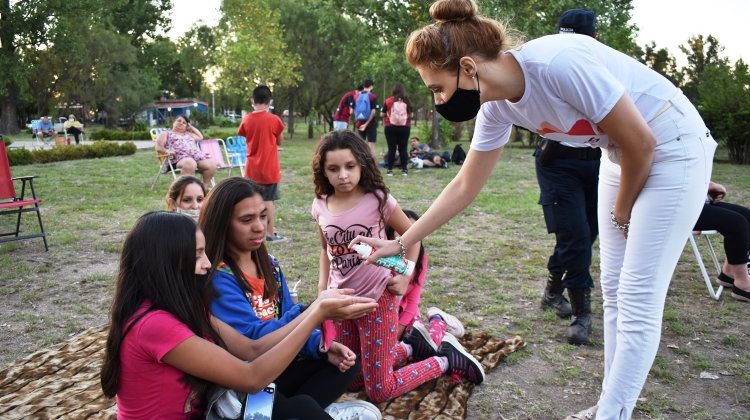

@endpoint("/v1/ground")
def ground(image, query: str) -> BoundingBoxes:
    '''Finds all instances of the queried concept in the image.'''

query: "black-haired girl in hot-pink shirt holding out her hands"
[101,212,376,419]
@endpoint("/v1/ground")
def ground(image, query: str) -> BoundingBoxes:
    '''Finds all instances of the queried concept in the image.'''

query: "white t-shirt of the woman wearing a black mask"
[471,35,679,151]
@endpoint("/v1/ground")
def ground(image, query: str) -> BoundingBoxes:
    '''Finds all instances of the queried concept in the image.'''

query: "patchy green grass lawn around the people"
[0,133,750,419]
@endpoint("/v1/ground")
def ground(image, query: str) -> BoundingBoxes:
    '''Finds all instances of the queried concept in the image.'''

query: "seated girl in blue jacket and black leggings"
[200,178,380,418]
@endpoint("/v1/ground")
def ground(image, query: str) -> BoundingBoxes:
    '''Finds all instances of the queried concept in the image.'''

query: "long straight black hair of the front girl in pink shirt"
[101,212,224,398]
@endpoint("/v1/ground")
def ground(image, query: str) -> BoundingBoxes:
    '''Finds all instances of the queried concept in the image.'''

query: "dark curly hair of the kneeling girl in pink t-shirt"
[312,130,390,231]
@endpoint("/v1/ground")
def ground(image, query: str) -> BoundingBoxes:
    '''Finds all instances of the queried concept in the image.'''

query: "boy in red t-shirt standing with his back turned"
[237,85,286,242]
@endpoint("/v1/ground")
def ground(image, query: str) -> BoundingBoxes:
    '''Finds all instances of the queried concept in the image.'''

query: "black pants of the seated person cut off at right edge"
[695,201,750,265]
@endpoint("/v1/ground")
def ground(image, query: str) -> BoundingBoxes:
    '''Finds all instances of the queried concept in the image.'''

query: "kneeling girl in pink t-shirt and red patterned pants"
[312,130,484,402]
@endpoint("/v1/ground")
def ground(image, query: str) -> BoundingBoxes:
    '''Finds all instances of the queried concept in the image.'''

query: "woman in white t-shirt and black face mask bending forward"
[353,0,716,419]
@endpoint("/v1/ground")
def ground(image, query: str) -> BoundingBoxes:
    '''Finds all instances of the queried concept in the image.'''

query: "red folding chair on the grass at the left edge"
[0,141,49,251]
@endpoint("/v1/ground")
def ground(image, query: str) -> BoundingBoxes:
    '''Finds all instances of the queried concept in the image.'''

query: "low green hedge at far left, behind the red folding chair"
[8,142,136,166]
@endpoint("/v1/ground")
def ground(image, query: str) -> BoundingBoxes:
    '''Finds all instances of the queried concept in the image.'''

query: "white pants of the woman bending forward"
[596,94,716,420]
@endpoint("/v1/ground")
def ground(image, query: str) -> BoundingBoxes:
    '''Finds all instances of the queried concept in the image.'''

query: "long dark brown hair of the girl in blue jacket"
[198,177,278,299]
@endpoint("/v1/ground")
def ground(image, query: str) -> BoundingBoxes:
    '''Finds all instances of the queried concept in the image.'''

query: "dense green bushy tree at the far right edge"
[697,60,750,164]
